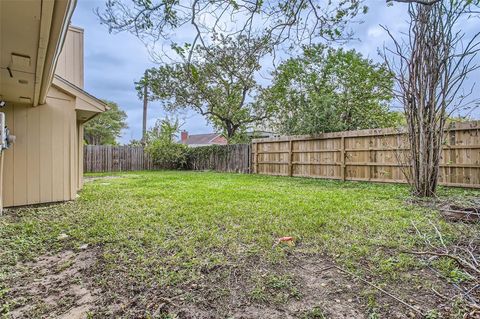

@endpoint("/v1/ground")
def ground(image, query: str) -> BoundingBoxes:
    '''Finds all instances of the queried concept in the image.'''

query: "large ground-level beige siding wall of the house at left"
[2,88,81,207]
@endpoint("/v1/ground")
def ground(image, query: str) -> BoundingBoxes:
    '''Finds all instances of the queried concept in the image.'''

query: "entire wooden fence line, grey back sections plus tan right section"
[84,121,480,188]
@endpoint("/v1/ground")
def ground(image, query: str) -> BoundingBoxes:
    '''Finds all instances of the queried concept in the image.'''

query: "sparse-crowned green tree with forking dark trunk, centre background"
[143,36,270,140]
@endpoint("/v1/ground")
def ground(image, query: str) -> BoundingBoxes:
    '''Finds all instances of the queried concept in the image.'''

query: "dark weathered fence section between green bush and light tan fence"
[189,144,252,173]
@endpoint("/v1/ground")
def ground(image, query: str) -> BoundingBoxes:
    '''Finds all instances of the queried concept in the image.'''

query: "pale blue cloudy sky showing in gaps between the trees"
[72,0,480,143]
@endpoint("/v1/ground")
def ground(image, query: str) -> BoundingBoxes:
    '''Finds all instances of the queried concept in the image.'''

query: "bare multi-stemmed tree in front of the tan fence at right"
[384,0,480,197]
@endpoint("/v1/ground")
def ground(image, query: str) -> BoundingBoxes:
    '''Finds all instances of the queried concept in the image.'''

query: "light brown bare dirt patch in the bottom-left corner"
[10,249,98,319]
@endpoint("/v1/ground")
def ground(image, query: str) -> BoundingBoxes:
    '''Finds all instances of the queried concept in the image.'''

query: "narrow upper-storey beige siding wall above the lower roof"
[55,27,83,89]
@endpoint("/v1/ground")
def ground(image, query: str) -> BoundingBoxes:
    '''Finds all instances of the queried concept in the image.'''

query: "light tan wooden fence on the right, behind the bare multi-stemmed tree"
[252,121,480,188]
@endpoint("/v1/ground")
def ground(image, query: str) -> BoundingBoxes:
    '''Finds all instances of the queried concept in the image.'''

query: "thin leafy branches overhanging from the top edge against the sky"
[96,0,367,60]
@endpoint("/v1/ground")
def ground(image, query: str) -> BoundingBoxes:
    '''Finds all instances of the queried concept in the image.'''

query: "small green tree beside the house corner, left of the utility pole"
[84,101,128,145]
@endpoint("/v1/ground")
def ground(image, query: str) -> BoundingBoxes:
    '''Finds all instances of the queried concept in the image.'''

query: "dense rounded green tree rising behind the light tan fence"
[268,45,401,134]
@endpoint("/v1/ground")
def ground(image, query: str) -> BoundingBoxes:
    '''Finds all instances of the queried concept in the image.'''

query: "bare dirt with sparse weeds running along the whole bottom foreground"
[3,248,466,319]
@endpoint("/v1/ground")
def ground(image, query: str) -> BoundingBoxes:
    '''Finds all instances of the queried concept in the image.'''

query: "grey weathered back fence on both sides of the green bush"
[83,144,251,173]
